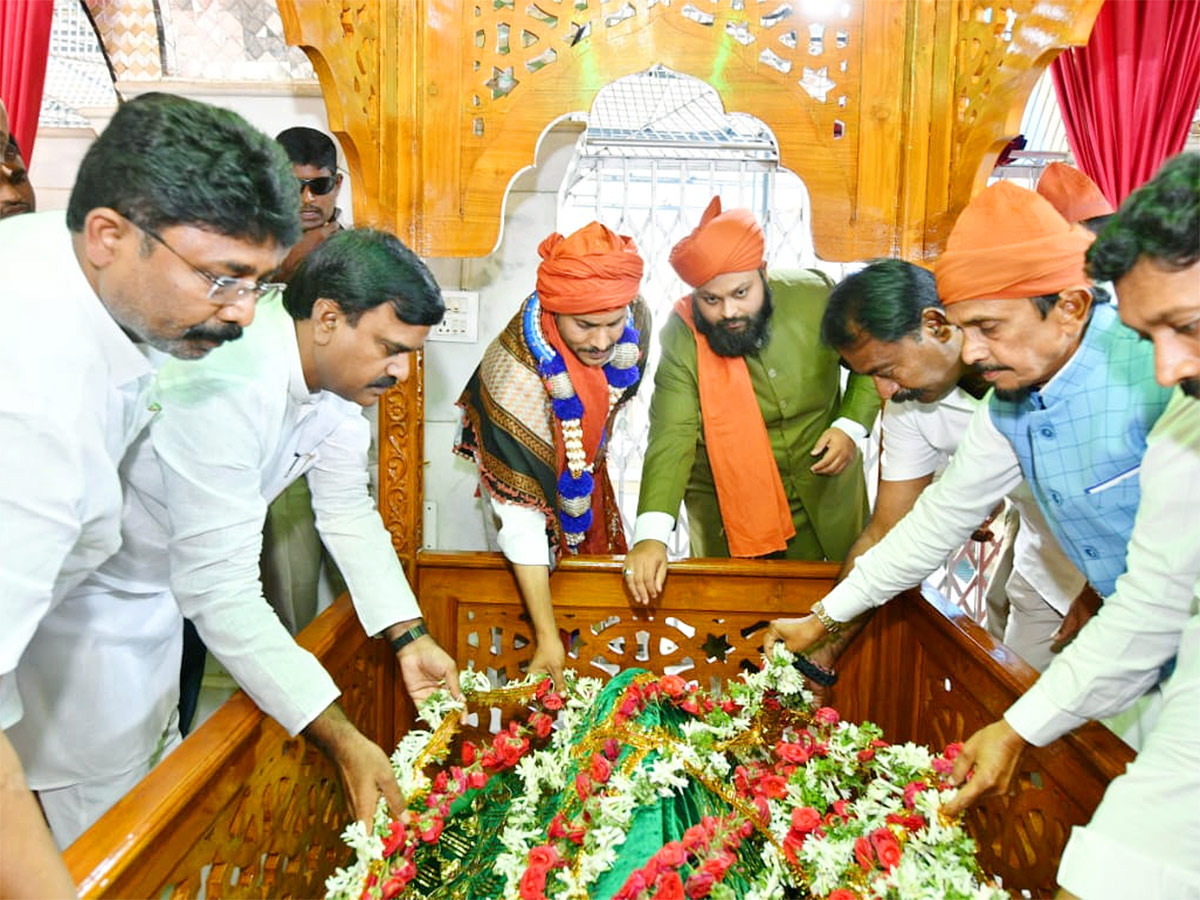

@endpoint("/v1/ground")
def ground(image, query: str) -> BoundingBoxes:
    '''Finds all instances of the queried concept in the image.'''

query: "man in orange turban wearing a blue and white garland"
[454,222,649,680]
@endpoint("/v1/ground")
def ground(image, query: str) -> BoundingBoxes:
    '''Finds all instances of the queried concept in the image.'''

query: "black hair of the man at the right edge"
[1087,152,1200,281]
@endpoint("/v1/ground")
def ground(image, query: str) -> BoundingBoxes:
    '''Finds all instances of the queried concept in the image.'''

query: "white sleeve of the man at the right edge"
[1004,390,1200,746]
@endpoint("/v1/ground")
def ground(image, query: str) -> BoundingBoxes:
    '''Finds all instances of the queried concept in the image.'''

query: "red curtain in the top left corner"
[0,0,54,166]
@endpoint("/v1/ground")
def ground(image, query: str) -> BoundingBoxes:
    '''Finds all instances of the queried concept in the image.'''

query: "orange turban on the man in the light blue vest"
[934,181,1096,306]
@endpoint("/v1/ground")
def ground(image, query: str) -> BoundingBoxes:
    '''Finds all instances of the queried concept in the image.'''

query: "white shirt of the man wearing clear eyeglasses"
[0,212,152,727]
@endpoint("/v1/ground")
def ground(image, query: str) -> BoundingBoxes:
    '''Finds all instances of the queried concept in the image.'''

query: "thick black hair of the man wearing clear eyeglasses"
[67,92,300,246]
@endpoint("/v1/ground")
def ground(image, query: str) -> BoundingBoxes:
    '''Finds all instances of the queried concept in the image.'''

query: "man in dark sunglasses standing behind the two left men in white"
[275,126,342,281]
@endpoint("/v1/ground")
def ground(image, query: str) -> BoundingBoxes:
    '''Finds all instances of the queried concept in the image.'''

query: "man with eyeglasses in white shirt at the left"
[0,94,299,896]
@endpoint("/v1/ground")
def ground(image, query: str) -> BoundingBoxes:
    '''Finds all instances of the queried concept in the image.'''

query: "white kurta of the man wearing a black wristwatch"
[14,292,420,801]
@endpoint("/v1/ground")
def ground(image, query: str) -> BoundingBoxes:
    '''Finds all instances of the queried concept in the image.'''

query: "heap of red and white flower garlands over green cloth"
[326,648,1008,900]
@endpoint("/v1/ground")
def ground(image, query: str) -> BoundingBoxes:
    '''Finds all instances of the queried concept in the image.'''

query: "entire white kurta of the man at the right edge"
[1004,391,1200,900]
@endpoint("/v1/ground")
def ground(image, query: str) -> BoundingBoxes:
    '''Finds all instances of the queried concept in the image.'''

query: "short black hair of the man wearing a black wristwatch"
[283,228,445,325]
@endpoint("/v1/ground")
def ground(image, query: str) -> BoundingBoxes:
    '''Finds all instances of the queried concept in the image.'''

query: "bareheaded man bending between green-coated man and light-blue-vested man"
[818,259,1099,671]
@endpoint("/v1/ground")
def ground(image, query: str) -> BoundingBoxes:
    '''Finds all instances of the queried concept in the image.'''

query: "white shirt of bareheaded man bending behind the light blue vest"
[880,388,1087,613]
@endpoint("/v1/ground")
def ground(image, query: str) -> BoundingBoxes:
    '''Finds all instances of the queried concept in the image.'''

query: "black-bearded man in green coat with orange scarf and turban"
[625,197,880,604]
